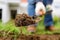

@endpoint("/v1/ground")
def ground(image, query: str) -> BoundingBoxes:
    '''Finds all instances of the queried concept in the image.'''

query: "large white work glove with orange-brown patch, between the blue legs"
[35,2,46,16]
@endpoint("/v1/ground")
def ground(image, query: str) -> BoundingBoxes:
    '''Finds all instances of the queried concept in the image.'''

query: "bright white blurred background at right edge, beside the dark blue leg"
[52,0,60,18]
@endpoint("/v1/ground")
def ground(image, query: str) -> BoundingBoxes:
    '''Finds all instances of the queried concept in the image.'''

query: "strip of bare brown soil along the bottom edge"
[0,35,60,40]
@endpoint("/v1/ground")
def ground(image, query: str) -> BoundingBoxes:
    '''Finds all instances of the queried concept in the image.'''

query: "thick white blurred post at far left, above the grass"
[2,4,10,23]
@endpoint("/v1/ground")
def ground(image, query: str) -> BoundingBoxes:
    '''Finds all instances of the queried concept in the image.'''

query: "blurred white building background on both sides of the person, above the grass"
[0,0,60,23]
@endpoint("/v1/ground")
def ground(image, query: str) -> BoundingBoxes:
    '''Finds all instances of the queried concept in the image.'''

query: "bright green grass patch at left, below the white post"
[0,21,20,36]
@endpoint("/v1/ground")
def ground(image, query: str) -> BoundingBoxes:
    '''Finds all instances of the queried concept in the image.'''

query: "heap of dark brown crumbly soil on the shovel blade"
[15,14,35,27]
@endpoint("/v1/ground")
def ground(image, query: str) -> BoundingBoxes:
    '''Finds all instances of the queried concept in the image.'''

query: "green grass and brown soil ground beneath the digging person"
[0,16,60,40]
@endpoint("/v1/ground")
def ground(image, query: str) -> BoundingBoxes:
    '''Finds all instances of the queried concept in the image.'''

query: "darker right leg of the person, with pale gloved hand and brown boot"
[43,0,54,31]
